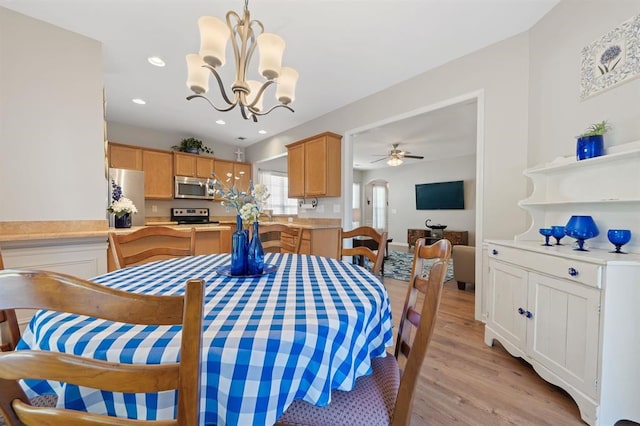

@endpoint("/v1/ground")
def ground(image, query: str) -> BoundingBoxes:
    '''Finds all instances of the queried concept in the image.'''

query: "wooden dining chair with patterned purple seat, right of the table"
[276,238,451,426]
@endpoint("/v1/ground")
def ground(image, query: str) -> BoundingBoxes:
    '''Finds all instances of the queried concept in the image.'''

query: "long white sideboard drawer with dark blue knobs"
[489,244,602,288]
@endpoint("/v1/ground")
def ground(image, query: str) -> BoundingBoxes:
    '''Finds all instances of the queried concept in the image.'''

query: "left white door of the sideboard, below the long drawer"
[487,259,527,355]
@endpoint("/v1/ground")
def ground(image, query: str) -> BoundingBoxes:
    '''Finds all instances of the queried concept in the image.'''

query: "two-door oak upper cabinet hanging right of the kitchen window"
[287,132,342,198]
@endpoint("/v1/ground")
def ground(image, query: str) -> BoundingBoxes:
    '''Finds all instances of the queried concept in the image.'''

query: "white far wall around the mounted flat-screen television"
[361,155,476,245]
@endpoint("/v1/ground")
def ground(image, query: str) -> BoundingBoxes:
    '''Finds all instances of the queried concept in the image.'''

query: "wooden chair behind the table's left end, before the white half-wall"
[109,226,196,269]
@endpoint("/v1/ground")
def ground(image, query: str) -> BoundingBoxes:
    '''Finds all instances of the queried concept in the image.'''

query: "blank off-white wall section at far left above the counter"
[0,7,107,221]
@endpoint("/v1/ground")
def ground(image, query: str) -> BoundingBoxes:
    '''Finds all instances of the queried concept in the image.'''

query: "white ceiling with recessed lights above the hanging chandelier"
[0,0,558,164]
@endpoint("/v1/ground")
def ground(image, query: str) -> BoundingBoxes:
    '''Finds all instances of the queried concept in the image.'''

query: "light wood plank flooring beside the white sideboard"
[384,278,584,426]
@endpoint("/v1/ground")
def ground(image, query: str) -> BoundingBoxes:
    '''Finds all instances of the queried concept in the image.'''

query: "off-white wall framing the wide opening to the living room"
[247,34,529,238]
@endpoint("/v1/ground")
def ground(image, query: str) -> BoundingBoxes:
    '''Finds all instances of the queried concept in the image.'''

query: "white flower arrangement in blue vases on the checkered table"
[209,172,271,225]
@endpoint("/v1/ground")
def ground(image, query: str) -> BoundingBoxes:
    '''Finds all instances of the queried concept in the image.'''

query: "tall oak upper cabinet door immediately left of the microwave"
[142,150,173,200]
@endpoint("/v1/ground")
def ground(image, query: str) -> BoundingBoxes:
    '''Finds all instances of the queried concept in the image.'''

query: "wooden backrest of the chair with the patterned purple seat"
[392,238,451,426]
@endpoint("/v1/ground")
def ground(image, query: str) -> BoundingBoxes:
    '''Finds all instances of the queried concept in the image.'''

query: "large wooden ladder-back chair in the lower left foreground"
[0,270,204,426]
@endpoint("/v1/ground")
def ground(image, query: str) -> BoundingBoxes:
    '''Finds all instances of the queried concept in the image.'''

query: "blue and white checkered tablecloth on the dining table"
[18,253,393,425]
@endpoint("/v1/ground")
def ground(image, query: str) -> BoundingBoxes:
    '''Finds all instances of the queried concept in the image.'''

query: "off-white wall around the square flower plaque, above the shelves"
[529,0,640,166]
